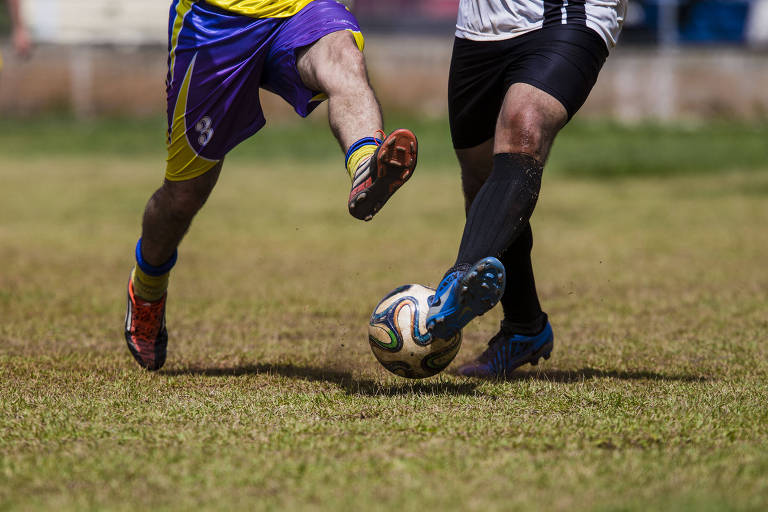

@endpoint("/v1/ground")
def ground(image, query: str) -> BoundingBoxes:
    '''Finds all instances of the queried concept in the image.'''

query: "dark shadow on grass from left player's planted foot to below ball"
[166,363,480,396]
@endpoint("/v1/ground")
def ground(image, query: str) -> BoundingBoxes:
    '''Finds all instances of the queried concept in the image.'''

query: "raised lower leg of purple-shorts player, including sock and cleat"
[297,31,418,220]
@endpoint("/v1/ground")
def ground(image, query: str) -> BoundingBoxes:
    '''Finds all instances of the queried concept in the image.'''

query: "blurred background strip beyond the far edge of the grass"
[0,0,768,122]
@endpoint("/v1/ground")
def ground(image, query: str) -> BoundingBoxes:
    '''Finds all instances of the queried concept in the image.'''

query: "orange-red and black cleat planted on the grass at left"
[125,279,168,371]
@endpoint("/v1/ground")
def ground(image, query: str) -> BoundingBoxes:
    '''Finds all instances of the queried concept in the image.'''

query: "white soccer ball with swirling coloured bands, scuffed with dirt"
[368,284,461,379]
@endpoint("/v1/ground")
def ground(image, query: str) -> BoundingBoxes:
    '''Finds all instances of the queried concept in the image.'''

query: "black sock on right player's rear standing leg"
[499,223,546,326]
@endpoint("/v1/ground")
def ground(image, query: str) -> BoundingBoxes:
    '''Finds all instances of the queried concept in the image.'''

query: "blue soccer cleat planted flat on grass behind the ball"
[458,321,555,377]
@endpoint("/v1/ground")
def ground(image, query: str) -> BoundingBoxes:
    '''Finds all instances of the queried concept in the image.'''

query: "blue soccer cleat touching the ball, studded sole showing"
[427,257,506,339]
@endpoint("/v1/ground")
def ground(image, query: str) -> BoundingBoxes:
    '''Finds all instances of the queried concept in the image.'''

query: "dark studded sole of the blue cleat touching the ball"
[427,258,506,339]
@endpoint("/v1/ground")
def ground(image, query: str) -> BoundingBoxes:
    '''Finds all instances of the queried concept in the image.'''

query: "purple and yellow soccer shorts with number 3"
[165,0,363,181]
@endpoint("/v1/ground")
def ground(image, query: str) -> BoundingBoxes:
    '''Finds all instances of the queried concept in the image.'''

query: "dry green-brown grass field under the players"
[0,119,768,511]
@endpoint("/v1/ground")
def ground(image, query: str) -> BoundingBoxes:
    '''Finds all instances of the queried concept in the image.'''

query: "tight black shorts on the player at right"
[448,25,608,149]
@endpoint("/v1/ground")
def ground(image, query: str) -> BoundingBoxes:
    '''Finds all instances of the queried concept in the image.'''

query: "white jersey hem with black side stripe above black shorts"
[456,0,627,48]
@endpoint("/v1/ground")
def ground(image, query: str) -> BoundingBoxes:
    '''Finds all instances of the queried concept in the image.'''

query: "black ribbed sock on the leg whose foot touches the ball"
[456,153,543,266]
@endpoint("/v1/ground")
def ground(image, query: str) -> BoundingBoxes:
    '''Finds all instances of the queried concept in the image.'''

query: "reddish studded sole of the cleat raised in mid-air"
[349,128,419,221]
